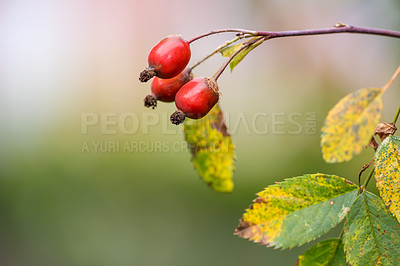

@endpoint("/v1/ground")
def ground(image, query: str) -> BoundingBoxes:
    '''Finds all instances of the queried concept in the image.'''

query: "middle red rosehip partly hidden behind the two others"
[144,67,193,109]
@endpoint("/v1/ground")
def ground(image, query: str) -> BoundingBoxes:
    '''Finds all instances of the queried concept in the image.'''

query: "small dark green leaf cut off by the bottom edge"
[297,239,347,266]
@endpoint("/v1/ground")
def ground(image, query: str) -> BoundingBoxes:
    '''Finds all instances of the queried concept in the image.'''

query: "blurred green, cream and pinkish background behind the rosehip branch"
[0,0,400,266]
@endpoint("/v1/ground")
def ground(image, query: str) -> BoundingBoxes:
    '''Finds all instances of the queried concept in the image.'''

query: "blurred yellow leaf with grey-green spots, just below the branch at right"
[321,88,383,163]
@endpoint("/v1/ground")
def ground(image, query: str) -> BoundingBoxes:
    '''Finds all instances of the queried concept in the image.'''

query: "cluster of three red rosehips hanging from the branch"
[139,36,219,125]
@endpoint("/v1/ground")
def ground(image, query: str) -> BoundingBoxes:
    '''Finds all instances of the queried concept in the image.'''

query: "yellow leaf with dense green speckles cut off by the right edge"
[375,136,400,221]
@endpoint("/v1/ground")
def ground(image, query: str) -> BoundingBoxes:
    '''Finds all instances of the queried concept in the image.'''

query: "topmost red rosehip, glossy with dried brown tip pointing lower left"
[139,35,191,82]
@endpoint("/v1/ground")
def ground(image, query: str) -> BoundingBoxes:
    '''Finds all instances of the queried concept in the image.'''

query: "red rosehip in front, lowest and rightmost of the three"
[170,78,219,125]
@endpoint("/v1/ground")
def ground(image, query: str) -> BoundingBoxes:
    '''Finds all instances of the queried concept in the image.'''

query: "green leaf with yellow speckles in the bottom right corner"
[343,191,400,265]
